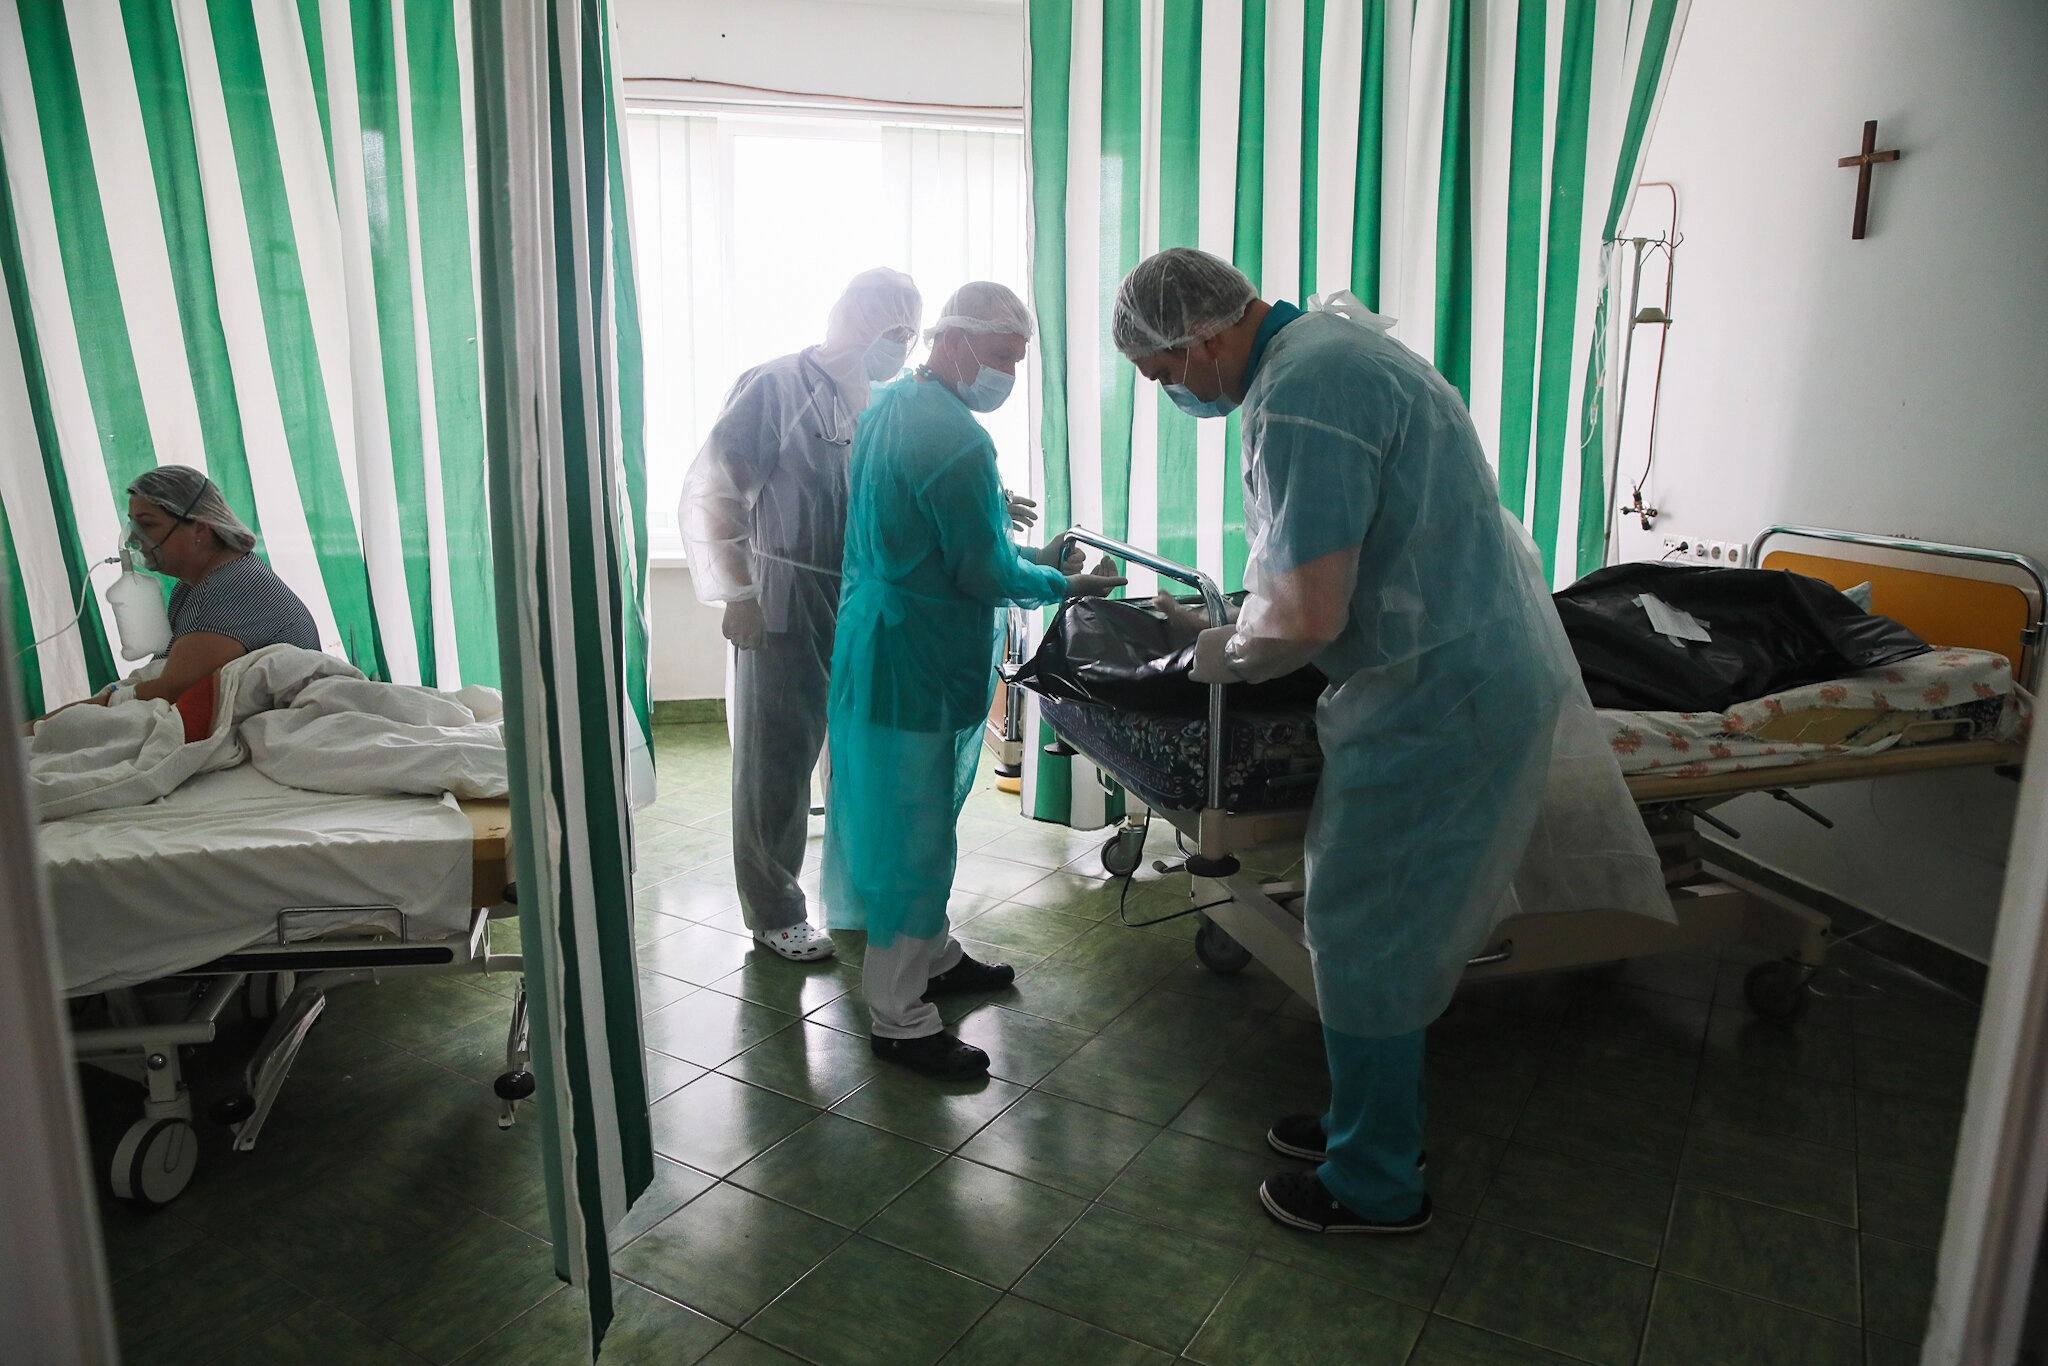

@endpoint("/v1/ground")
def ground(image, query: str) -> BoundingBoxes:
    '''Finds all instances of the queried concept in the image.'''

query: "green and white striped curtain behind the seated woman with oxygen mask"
[0,0,645,741]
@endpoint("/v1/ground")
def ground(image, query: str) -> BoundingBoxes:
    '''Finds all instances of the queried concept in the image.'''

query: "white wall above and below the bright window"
[618,0,1024,702]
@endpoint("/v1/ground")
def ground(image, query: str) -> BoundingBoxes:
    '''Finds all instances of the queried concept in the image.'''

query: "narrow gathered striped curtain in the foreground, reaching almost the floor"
[475,0,653,1348]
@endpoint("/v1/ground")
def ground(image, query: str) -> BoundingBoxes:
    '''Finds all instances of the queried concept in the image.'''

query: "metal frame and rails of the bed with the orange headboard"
[1061,526,2048,1020]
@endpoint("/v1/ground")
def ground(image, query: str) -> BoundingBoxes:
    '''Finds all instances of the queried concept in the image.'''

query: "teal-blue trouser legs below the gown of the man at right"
[1315,1024,1425,1221]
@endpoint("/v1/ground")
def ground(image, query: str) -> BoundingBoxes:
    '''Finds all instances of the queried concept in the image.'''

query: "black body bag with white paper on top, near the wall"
[1554,563,1929,711]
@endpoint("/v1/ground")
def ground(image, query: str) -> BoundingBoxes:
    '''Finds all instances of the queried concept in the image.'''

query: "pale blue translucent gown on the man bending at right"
[1227,311,1671,1038]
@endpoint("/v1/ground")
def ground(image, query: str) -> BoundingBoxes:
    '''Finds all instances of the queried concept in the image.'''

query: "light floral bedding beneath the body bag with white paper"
[1599,649,2034,778]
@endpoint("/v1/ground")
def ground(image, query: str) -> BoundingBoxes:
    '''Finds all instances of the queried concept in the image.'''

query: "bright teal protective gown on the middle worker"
[823,379,1067,948]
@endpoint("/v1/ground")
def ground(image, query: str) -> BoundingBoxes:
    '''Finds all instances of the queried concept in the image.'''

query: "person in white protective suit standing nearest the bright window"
[680,268,924,963]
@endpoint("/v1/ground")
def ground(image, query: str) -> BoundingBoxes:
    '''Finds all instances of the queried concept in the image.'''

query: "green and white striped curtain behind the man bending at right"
[1026,0,1690,819]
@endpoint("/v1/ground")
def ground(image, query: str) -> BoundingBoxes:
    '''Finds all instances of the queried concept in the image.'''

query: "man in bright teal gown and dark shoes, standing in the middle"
[825,283,1122,1079]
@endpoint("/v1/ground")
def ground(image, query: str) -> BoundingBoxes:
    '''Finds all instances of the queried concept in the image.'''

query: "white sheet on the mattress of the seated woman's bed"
[39,766,471,993]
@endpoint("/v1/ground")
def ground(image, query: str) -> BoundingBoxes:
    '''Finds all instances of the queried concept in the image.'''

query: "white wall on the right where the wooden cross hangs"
[1618,0,2048,958]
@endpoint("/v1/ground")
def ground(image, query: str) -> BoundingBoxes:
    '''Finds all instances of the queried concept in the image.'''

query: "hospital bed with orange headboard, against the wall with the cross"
[1036,526,2048,1020]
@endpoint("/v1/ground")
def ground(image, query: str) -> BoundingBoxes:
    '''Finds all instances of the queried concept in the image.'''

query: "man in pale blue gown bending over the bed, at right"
[1112,248,1669,1233]
